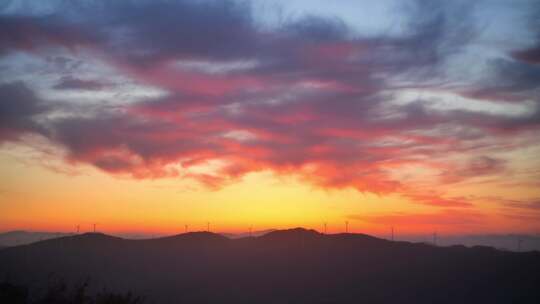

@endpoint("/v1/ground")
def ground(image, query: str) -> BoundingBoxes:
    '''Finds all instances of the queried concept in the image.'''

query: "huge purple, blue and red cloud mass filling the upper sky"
[0,0,540,197]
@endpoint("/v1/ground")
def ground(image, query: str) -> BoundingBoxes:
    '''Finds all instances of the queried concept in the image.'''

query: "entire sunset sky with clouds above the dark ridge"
[0,0,540,235]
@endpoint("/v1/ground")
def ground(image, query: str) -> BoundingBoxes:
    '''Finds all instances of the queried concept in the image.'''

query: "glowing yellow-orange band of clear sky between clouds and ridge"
[0,141,538,235]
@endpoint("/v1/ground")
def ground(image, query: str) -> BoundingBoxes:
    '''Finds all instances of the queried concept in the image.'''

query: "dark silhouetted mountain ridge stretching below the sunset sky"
[0,229,540,303]
